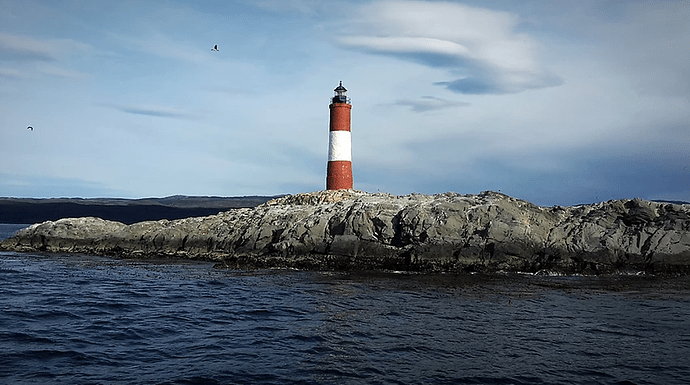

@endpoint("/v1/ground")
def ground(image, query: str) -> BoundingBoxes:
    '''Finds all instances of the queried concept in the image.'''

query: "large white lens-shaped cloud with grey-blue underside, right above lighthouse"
[336,0,563,94]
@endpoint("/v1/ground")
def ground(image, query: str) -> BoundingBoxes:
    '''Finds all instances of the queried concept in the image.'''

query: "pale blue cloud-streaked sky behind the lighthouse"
[0,0,690,206]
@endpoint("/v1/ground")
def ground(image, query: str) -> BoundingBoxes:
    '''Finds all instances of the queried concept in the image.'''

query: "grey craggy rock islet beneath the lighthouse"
[0,190,690,275]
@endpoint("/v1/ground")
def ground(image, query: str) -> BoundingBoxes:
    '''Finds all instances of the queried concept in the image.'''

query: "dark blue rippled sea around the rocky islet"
[0,224,690,384]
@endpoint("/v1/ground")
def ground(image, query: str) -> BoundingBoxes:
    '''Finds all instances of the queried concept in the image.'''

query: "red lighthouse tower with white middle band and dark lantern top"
[326,81,352,190]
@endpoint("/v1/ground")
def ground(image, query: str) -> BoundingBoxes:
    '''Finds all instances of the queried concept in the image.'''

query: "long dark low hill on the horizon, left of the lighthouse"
[0,195,282,224]
